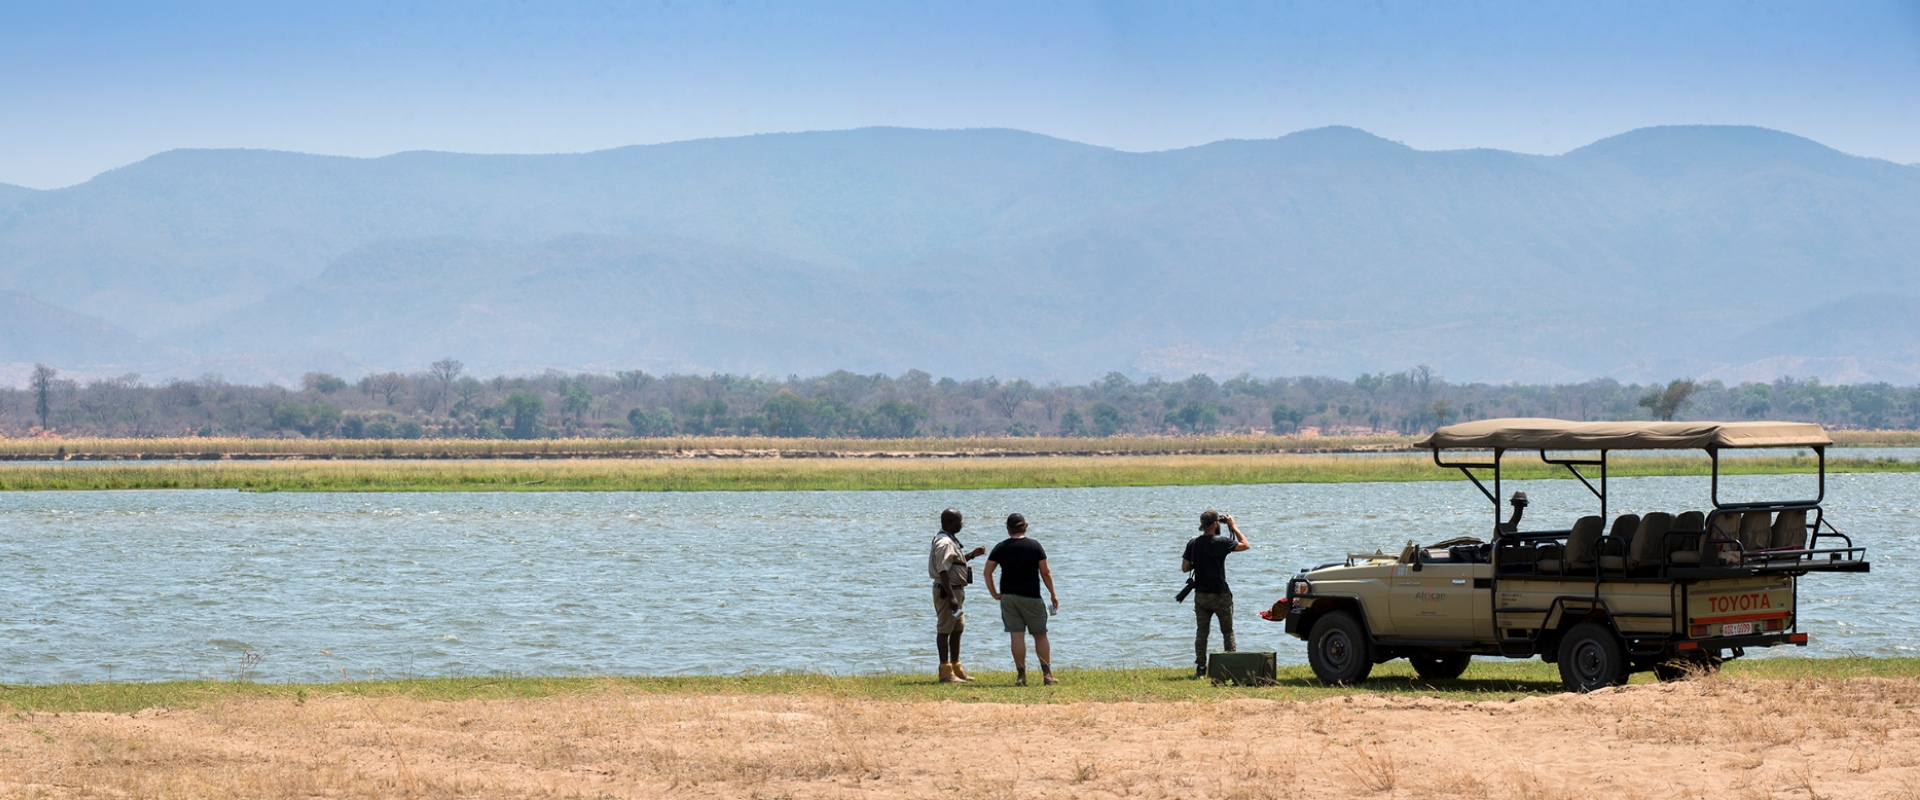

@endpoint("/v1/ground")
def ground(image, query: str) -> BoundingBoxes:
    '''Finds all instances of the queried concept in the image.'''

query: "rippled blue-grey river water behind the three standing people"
[0,474,1920,683]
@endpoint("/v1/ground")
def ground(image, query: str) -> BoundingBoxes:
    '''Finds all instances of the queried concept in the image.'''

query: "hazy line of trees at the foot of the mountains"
[0,359,1920,439]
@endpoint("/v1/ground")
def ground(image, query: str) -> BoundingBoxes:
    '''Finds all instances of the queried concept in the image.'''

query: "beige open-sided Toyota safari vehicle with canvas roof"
[1269,418,1868,691]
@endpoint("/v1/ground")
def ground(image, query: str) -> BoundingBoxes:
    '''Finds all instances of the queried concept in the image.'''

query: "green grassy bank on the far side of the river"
[0,455,1920,491]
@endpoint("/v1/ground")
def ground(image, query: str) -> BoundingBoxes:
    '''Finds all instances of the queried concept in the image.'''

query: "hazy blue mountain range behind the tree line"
[0,127,1920,384]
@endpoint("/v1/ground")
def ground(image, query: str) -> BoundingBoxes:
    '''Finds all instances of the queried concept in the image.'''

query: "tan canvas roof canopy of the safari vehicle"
[1413,418,1834,451]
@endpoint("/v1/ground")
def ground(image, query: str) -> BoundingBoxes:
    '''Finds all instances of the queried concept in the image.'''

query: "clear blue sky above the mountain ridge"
[0,0,1920,188]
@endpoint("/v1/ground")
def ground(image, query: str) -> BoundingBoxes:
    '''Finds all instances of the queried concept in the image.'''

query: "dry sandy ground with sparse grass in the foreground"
[0,679,1920,800]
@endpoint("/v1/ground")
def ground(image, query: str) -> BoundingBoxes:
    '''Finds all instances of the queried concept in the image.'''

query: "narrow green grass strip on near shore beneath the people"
[0,654,1920,714]
